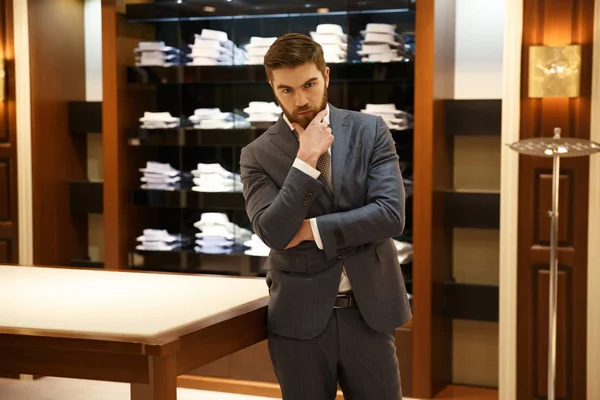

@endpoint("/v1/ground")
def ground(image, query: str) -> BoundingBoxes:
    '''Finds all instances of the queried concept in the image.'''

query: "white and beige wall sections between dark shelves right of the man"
[453,0,505,387]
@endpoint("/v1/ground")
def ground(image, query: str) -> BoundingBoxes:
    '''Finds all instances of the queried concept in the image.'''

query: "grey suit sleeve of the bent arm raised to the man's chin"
[240,147,322,250]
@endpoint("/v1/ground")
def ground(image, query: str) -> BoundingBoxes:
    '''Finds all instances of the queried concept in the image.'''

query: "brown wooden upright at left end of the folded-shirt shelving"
[102,0,156,269]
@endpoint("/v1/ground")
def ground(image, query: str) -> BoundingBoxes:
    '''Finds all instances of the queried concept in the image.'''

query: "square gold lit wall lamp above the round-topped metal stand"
[529,45,581,98]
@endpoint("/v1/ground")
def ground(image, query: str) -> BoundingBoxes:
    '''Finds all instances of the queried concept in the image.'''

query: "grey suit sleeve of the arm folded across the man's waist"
[316,117,405,258]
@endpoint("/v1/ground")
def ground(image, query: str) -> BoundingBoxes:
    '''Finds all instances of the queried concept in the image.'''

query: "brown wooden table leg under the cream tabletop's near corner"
[131,356,177,400]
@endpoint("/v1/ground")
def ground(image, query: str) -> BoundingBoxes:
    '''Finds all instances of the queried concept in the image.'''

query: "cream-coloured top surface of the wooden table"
[0,265,269,341]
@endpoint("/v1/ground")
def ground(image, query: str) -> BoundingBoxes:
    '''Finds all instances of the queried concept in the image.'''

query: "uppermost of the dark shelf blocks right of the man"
[444,100,502,137]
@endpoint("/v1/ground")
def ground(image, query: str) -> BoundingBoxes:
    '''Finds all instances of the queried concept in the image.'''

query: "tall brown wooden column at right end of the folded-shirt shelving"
[411,0,456,398]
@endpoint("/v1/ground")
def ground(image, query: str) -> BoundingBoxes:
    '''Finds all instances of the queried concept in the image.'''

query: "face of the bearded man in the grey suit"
[269,63,329,128]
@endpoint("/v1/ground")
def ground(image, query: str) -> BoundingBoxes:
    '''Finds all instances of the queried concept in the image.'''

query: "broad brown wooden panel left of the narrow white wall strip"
[28,0,87,265]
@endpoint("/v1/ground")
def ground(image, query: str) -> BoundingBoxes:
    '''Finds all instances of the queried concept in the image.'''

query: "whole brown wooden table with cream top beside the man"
[0,266,268,400]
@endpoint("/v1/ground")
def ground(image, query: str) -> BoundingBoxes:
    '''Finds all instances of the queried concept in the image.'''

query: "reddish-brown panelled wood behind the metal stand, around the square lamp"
[517,0,594,400]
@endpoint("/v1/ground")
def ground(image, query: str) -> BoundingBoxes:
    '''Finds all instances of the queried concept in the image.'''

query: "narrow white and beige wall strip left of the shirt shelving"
[84,0,104,261]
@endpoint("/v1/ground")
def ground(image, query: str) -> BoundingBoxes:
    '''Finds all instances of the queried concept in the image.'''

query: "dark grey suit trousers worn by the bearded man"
[268,307,402,400]
